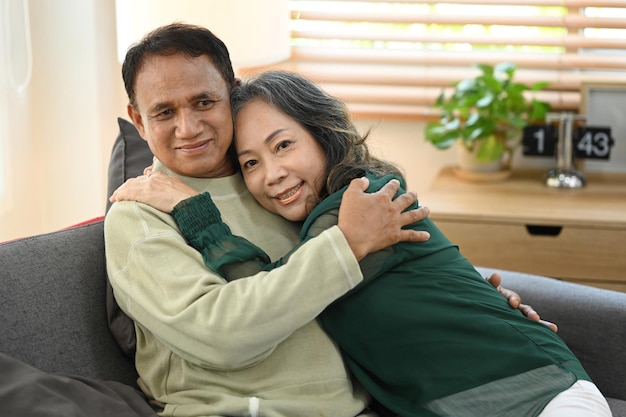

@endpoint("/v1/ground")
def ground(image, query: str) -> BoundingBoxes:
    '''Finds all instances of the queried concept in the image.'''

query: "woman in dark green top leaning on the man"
[108,72,611,417]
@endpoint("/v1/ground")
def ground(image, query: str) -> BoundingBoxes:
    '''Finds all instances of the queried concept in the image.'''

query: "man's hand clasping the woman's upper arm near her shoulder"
[338,178,430,260]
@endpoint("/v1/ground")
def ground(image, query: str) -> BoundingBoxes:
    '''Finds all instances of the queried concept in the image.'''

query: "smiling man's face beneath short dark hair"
[128,54,234,178]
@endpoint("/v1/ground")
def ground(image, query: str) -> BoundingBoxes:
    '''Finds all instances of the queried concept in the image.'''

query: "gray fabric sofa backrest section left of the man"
[0,221,137,386]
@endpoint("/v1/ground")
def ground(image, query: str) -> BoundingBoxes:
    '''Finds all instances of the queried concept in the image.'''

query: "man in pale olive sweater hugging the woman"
[105,24,428,417]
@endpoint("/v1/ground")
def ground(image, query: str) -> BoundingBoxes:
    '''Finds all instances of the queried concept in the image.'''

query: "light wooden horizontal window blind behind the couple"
[245,0,626,120]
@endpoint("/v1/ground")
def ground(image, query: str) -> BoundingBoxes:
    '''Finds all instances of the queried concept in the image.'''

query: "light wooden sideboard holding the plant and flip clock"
[420,167,626,292]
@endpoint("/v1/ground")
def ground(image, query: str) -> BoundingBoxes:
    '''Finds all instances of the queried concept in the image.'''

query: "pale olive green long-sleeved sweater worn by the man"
[105,164,369,417]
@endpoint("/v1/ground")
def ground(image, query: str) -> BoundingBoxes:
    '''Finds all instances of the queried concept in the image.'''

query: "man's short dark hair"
[122,23,235,107]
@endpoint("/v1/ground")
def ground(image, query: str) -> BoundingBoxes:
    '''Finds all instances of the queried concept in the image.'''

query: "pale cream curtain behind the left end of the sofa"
[0,0,125,241]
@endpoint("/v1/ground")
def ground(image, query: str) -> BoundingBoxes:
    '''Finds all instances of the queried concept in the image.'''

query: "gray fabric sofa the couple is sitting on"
[0,220,626,417]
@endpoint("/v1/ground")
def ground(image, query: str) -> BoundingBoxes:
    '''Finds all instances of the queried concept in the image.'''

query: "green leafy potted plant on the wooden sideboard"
[425,62,550,177]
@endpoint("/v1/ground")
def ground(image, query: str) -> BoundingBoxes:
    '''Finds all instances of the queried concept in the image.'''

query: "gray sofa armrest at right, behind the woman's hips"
[478,268,626,400]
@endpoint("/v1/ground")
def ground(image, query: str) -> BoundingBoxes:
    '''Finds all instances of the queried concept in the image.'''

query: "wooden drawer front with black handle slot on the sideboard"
[432,218,626,291]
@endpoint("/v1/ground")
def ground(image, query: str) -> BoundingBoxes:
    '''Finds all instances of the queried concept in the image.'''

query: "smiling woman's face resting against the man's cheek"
[235,99,326,221]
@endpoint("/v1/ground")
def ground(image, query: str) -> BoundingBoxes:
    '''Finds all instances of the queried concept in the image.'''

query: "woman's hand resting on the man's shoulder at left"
[109,171,199,213]
